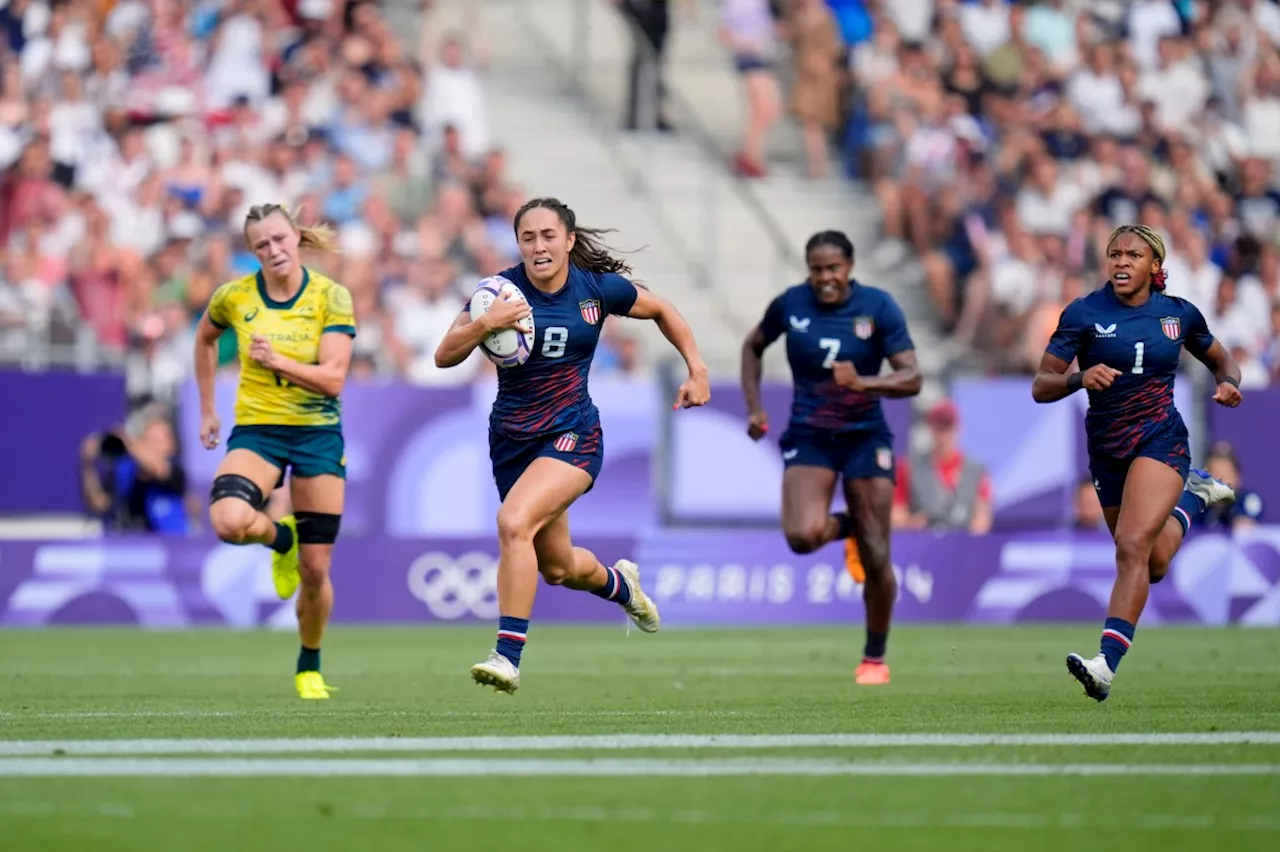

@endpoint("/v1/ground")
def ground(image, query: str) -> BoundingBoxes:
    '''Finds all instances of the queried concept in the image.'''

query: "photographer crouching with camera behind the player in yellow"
[81,406,187,535]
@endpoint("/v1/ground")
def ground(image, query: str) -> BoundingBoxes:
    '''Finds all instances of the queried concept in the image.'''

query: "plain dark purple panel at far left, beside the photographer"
[0,371,125,514]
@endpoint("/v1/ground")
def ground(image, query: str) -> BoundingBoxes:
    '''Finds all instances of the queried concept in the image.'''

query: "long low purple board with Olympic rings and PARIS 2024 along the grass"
[0,527,1280,629]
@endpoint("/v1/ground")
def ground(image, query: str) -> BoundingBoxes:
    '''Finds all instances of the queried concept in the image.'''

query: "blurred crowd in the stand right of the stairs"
[829,0,1280,386]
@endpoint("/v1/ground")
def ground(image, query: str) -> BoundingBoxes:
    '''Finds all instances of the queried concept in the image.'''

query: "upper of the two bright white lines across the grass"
[0,730,1280,756]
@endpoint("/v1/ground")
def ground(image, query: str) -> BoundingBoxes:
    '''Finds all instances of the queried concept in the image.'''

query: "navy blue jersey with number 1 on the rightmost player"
[1047,283,1213,459]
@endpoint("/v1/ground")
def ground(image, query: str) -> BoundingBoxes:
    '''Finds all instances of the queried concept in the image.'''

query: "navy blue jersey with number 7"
[760,281,915,432]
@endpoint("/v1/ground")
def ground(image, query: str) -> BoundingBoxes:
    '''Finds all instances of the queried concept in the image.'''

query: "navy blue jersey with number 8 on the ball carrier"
[489,265,637,438]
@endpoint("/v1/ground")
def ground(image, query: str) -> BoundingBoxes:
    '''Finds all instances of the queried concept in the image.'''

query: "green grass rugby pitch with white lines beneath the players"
[0,624,1280,852]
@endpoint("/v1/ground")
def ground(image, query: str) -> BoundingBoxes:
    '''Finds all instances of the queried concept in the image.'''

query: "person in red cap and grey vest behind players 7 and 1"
[893,399,993,535]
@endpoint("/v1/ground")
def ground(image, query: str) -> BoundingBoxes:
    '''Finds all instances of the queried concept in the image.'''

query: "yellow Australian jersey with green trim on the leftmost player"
[209,269,356,427]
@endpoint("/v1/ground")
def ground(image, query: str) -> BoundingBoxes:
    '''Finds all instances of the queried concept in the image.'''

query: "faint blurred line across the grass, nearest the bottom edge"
[0,798,1280,833]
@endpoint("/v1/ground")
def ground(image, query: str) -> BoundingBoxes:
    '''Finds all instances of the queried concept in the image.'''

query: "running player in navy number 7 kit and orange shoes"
[742,230,920,686]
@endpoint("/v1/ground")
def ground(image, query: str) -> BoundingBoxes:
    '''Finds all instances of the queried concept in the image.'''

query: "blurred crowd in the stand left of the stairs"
[0,0,636,409]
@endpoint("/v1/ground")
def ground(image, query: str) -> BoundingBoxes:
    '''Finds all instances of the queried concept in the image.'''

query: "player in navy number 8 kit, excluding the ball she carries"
[435,198,710,692]
